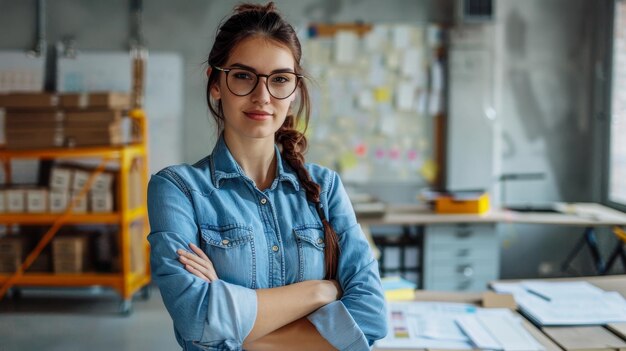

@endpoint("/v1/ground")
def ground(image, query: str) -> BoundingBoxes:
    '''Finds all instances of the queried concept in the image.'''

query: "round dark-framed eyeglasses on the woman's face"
[213,66,304,100]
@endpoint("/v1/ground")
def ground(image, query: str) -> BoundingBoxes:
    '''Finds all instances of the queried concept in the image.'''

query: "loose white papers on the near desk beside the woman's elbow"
[376,302,544,351]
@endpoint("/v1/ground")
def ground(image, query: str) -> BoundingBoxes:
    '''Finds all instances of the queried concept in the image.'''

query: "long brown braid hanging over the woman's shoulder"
[275,115,340,279]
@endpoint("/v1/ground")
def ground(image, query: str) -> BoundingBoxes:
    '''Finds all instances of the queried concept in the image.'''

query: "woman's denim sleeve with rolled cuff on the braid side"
[308,172,387,350]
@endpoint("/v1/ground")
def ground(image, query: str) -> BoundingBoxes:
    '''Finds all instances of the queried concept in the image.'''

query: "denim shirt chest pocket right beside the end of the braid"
[293,226,326,281]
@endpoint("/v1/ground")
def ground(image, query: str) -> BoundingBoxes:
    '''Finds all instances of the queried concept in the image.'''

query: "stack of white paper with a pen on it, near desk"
[493,281,626,326]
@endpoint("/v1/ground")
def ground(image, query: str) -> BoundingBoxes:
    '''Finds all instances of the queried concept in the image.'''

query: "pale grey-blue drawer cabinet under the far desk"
[423,223,500,291]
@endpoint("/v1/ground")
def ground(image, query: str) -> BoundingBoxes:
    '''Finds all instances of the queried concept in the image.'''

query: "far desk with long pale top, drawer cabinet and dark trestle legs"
[355,203,626,291]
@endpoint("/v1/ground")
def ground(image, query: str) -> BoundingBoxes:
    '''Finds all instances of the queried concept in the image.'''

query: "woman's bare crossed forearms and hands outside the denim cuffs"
[177,244,341,351]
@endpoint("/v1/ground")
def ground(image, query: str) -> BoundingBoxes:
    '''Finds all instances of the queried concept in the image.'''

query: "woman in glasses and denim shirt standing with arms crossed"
[148,3,387,350]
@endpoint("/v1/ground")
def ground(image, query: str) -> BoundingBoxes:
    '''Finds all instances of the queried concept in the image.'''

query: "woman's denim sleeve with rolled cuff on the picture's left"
[148,171,257,350]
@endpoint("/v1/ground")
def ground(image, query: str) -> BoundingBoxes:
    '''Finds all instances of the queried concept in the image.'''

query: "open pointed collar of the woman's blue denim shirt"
[210,134,300,191]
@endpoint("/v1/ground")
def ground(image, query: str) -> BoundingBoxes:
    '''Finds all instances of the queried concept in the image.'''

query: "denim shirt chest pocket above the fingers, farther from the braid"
[200,224,256,289]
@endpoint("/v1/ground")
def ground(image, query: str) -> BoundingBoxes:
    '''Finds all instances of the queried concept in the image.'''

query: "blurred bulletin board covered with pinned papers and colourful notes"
[302,24,444,183]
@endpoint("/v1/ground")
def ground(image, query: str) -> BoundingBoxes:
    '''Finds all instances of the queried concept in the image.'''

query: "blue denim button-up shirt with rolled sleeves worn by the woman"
[148,137,387,350]
